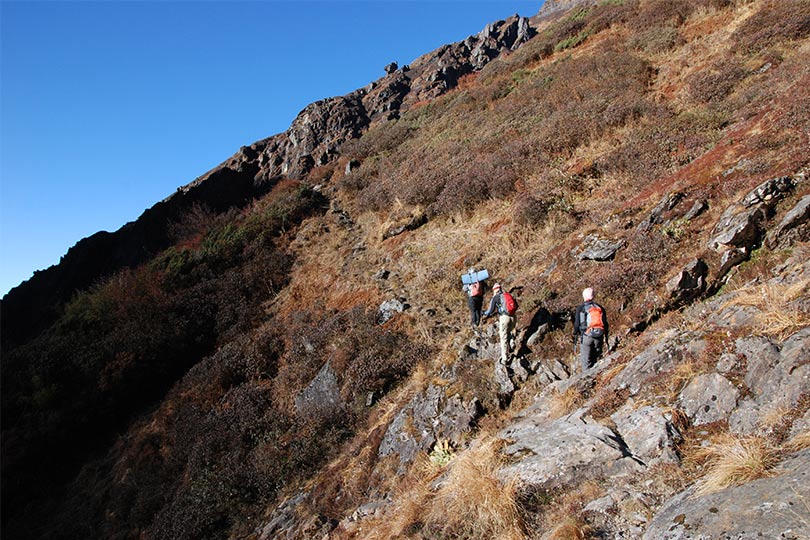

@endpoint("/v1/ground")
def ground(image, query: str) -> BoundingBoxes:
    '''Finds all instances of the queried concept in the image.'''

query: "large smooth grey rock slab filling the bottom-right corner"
[643,450,810,540]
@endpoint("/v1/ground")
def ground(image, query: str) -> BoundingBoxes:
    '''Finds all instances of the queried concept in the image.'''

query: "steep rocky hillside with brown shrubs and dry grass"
[2,0,810,540]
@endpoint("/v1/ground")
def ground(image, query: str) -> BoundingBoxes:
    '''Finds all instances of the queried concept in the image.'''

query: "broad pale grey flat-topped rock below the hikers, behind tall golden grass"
[499,409,643,486]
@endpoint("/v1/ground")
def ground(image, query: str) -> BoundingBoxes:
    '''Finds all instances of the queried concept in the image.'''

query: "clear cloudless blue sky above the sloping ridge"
[0,0,542,296]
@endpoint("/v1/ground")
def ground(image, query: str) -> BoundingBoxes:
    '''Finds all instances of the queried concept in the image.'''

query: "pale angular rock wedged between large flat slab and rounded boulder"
[610,405,682,466]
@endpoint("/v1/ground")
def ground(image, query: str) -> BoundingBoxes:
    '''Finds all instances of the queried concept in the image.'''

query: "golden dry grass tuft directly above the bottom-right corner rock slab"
[693,434,780,495]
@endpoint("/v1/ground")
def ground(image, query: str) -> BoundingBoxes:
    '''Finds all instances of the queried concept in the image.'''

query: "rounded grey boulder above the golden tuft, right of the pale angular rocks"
[678,373,740,425]
